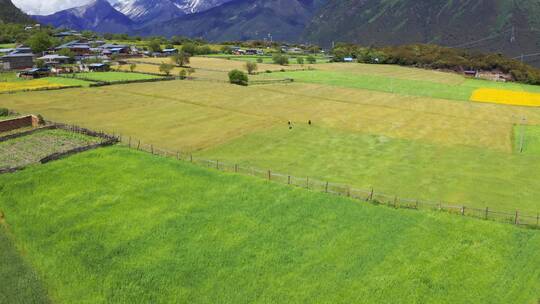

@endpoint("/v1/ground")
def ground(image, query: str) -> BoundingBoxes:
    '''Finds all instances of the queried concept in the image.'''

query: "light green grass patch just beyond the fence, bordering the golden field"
[197,125,540,216]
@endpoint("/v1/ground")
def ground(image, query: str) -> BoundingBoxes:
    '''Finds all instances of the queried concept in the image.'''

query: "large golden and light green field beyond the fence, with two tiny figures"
[0,58,540,214]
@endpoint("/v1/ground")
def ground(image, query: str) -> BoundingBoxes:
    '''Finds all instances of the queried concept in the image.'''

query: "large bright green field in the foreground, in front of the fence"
[0,147,540,303]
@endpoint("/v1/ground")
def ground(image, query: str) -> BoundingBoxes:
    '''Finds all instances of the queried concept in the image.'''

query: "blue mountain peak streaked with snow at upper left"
[33,0,134,33]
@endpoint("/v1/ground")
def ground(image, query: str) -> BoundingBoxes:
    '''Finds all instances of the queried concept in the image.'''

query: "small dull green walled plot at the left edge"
[0,130,99,168]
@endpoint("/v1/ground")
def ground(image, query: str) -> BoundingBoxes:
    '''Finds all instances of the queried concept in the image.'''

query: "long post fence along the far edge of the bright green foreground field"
[118,136,540,229]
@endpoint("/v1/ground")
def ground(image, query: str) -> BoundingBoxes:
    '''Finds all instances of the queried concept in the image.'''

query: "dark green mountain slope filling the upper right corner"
[304,0,540,60]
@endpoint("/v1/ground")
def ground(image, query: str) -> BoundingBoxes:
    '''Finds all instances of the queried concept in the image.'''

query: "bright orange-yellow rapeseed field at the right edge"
[471,88,540,107]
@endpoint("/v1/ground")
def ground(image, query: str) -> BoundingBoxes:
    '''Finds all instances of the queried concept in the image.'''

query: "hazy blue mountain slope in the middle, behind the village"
[137,0,321,41]
